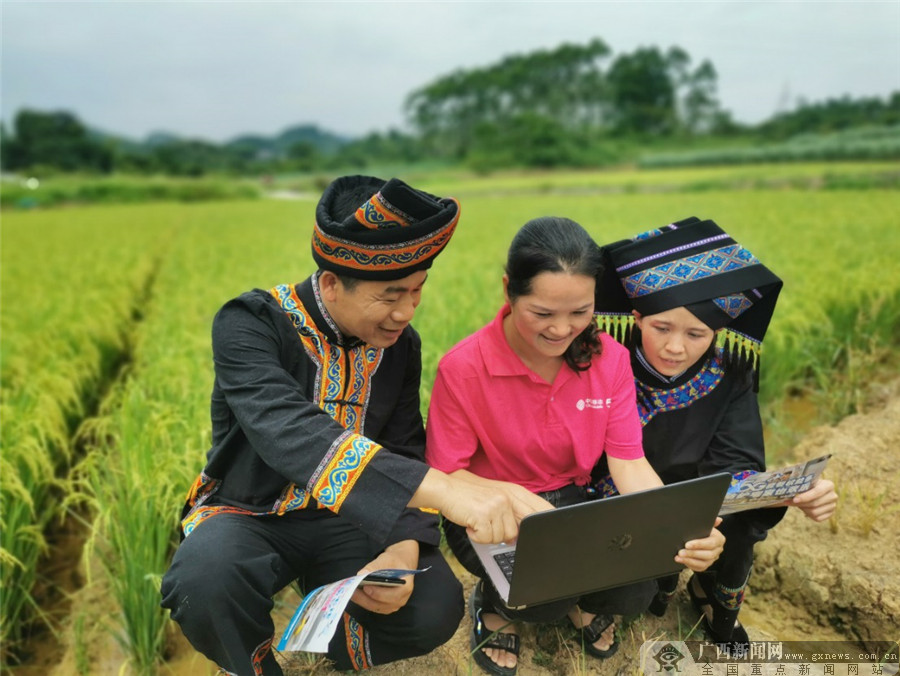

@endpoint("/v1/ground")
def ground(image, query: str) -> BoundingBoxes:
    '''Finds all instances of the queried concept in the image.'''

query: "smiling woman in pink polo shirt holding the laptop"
[426,218,724,676]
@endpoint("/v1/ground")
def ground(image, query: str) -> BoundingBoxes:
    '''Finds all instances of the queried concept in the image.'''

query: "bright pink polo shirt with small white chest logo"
[425,305,644,492]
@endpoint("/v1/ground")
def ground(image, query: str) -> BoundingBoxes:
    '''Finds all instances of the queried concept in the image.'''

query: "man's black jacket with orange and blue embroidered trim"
[182,275,440,546]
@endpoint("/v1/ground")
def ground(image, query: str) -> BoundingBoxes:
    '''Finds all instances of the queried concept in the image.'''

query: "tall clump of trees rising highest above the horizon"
[406,39,734,166]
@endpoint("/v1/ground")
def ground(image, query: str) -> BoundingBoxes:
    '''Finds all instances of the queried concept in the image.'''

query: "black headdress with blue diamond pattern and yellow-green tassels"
[595,217,782,367]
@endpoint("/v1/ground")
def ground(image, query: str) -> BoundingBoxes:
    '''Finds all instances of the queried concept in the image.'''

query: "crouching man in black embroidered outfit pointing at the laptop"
[162,176,544,676]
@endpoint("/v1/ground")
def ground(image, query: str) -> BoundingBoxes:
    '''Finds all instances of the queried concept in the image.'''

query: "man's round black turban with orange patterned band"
[312,176,459,280]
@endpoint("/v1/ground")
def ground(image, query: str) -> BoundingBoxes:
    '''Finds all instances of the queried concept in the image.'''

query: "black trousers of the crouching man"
[162,510,463,676]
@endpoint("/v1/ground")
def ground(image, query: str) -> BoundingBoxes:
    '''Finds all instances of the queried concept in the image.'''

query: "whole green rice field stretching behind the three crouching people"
[0,165,900,674]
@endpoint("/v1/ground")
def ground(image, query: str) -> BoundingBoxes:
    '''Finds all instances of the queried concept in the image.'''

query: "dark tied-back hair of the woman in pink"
[506,216,603,371]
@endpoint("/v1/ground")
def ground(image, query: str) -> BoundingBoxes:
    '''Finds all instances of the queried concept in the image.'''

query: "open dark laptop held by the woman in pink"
[472,473,731,608]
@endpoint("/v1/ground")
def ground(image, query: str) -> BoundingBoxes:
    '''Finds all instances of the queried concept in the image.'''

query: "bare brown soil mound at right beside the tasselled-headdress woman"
[752,380,900,645]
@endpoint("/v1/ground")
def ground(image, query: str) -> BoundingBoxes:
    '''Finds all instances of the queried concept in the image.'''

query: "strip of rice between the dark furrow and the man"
[67,197,309,674]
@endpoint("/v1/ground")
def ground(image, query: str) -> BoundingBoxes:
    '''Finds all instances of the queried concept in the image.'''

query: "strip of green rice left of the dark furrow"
[0,205,164,662]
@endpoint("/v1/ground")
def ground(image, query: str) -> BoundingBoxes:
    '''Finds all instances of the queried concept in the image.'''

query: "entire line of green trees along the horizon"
[0,38,900,176]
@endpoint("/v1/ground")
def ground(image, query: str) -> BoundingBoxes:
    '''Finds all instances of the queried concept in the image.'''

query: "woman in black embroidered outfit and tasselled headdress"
[595,218,837,643]
